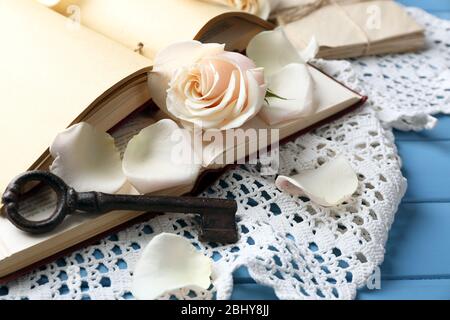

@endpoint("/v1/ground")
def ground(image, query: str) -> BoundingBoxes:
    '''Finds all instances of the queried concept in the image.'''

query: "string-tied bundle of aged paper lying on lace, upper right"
[275,0,425,59]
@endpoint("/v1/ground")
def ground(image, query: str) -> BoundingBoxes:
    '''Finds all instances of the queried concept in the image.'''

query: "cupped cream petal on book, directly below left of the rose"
[123,119,201,194]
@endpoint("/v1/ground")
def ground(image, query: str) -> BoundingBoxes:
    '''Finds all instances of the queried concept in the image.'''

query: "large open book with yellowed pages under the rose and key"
[0,0,365,279]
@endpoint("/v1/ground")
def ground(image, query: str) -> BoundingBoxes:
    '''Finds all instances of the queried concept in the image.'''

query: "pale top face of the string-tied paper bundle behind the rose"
[284,0,423,48]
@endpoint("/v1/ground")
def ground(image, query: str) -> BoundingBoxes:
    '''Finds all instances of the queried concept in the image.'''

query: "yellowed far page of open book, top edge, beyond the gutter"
[54,0,233,59]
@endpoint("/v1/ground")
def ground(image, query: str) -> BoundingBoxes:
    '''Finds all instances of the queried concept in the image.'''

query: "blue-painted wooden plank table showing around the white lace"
[233,0,450,300]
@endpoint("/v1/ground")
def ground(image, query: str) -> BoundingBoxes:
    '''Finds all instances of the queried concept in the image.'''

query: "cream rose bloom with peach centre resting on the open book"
[149,41,267,130]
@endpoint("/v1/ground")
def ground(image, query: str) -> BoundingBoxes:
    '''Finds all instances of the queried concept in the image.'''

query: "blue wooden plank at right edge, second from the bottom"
[381,203,450,280]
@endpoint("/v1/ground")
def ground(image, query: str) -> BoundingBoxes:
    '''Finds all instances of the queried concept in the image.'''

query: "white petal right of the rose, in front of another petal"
[260,63,315,125]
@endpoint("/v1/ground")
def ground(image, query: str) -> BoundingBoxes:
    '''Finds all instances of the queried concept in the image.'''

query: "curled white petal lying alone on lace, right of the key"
[275,156,358,207]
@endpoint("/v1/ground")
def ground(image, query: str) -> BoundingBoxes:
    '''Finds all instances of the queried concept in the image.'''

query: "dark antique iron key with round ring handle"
[2,171,238,243]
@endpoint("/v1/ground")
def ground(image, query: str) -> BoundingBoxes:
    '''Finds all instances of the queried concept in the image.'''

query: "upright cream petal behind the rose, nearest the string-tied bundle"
[247,27,304,78]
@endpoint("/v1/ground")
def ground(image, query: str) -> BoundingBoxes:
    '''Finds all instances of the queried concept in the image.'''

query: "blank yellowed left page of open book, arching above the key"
[0,0,150,192]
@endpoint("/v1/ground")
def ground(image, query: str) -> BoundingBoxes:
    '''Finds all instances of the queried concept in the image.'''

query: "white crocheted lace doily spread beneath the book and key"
[0,9,450,299]
